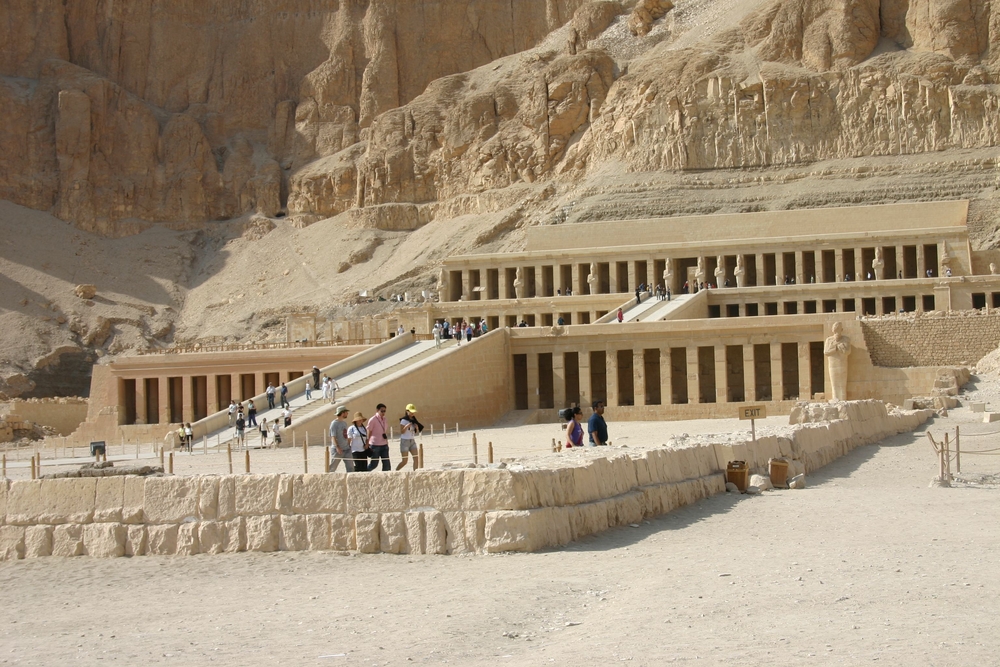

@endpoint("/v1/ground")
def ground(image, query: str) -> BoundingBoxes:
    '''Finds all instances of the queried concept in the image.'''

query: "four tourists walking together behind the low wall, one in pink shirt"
[330,403,424,472]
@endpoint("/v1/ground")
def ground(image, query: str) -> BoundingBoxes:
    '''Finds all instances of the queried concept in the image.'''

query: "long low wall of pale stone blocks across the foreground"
[0,401,932,559]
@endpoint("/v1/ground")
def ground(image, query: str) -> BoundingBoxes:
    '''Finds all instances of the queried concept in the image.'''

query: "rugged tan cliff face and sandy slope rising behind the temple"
[0,0,1000,395]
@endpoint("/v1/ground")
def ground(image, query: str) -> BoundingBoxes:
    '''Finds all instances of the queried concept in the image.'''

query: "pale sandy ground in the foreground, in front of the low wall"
[0,392,1000,665]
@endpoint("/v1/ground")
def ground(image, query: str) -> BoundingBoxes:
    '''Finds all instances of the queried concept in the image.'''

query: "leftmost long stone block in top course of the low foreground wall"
[7,478,97,525]
